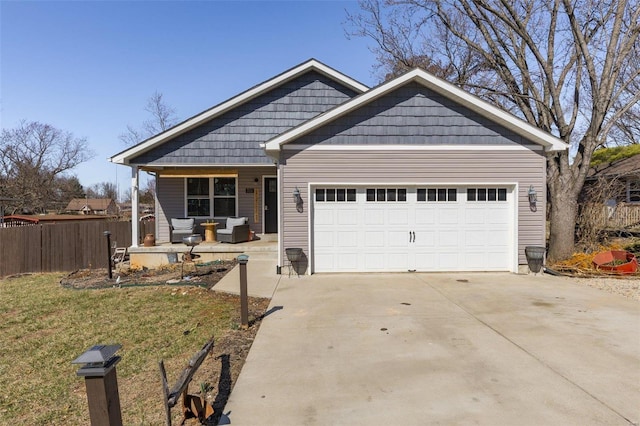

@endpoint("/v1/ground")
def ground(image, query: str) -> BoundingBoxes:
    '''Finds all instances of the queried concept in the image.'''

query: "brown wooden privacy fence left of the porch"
[0,221,139,277]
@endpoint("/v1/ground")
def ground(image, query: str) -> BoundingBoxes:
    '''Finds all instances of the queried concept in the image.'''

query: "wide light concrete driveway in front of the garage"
[221,273,640,425]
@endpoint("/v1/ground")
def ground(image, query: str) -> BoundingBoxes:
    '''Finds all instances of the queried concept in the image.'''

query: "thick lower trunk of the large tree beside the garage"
[547,185,578,263]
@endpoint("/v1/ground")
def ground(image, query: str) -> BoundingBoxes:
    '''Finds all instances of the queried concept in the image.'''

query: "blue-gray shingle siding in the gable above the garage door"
[295,82,524,145]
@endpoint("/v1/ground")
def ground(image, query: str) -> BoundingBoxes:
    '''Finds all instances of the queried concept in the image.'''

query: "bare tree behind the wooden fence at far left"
[0,121,93,213]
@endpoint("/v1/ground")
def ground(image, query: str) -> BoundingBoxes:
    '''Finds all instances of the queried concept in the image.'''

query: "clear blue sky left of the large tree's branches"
[0,0,377,199]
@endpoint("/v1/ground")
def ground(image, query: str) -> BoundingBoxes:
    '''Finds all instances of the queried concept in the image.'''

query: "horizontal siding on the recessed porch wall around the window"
[156,166,277,242]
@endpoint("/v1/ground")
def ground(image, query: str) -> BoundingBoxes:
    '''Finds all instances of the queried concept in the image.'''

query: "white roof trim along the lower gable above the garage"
[264,69,569,152]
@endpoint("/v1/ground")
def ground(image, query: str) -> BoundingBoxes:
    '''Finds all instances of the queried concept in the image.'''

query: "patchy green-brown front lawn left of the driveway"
[0,274,238,425]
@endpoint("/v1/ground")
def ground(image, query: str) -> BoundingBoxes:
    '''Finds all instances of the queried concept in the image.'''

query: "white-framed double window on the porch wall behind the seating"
[186,177,237,217]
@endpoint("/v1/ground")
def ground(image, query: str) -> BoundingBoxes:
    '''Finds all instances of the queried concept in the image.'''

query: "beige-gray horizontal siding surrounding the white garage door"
[280,147,546,264]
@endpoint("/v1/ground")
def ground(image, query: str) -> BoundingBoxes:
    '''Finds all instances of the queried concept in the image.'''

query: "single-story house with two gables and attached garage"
[110,59,567,273]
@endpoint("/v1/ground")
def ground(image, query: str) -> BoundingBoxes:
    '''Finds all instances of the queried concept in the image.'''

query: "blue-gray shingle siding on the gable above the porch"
[131,71,356,165]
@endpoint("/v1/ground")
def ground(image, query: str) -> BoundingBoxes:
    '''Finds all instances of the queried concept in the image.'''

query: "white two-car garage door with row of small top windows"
[311,186,515,272]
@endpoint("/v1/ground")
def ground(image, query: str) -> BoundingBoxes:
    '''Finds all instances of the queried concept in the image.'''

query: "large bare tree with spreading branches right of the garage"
[347,0,640,260]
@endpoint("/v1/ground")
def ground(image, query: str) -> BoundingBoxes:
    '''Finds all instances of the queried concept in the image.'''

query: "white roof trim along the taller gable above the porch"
[109,59,369,164]
